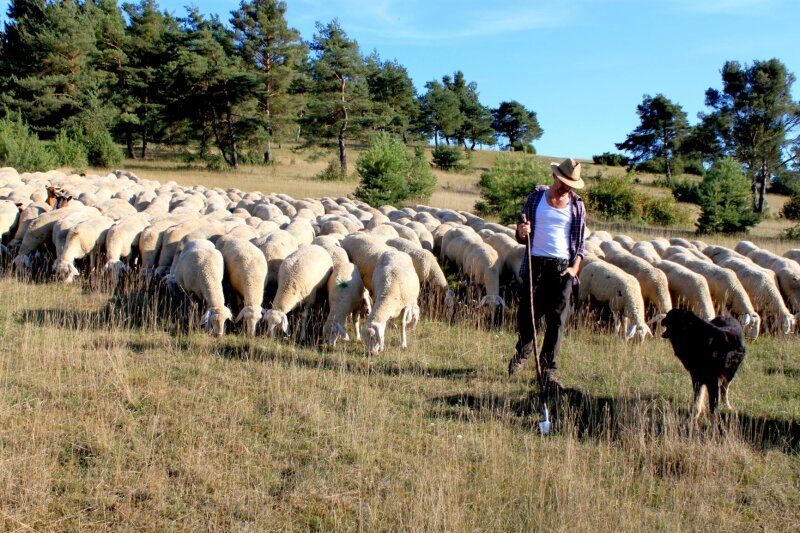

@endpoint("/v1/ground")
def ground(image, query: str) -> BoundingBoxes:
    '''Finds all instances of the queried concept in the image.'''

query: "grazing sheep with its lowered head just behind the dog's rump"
[670,253,761,339]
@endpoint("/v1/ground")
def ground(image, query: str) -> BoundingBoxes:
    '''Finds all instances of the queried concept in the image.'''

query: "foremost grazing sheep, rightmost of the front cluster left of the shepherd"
[364,248,420,354]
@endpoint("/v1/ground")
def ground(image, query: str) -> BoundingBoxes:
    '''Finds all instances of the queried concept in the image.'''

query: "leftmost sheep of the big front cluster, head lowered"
[166,240,233,337]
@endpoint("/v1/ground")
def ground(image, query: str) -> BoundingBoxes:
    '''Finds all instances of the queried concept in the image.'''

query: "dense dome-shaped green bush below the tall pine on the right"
[697,158,761,233]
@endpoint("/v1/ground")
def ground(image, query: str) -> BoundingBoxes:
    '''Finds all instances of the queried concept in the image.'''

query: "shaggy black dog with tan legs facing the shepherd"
[661,309,745,421]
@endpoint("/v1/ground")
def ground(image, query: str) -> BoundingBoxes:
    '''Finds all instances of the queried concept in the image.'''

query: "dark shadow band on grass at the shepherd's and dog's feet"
[431,388,800,453]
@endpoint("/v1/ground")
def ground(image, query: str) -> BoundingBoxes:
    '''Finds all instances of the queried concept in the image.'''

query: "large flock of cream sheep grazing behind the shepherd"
[0,168,800,353]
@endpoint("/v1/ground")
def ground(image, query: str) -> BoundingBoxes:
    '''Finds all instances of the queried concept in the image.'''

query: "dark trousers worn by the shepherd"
[514,257,574,371]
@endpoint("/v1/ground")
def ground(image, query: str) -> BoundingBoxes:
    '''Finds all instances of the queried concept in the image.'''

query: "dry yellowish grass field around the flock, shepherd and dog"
[0,144,800,532]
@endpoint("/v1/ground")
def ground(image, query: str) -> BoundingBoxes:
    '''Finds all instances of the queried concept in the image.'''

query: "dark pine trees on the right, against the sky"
[608,59,800,213]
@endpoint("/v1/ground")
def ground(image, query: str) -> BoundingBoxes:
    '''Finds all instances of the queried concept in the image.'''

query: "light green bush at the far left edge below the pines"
[0,118,58,172]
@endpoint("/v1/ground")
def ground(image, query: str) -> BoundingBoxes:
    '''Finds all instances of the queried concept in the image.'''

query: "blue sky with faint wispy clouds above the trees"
[6,0,800,158]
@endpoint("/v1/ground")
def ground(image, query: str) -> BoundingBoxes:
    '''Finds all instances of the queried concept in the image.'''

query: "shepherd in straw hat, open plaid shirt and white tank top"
[508,159,586,388]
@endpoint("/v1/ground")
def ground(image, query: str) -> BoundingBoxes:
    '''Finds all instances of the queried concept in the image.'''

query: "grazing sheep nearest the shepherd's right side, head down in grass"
[578,261,652,341]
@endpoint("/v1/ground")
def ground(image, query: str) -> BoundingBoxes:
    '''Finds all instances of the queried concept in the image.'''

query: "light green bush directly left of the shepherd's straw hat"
[475,153,553,224]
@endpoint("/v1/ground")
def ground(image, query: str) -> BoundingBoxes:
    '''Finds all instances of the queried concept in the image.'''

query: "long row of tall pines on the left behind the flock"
[0,0,543,172]
